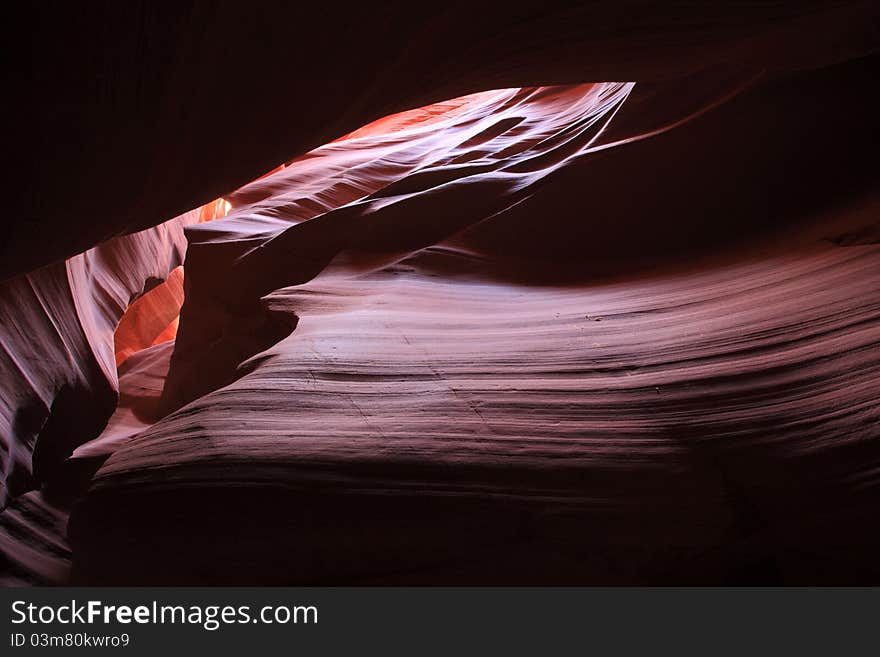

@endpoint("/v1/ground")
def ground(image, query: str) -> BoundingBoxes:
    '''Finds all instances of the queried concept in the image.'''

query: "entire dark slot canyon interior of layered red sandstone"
[0,0,880,586]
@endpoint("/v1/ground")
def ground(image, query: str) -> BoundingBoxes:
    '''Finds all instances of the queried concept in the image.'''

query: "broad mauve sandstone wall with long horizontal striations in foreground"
[71,242,880,584]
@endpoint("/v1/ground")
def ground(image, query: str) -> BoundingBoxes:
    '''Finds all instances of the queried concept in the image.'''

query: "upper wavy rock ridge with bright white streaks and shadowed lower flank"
[163,74,753,410]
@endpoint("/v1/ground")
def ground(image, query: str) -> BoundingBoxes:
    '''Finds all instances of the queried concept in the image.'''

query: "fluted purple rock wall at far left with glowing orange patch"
[0,200,229,506]
